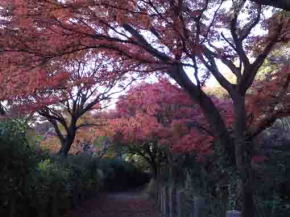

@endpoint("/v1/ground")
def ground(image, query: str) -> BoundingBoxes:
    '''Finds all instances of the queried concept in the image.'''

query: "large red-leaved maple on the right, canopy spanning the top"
[0,0,290,217]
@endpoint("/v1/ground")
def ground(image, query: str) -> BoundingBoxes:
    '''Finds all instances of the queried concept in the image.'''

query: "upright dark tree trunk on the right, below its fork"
[233,95,255,217]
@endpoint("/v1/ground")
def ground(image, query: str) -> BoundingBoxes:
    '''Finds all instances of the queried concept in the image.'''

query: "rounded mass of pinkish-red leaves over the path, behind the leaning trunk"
[107,79,239,158]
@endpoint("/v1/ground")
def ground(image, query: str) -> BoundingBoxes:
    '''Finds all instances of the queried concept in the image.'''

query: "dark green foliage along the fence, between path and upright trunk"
[159,154,232,217]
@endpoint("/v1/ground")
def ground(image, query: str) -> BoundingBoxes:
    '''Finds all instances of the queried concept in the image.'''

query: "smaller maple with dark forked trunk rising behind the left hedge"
[23,56,129,156]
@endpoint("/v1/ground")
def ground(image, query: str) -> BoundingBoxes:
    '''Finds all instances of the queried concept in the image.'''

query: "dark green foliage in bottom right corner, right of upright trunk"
[256,149,290,217]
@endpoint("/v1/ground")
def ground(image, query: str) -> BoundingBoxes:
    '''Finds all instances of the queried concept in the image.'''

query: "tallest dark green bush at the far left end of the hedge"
[0,120,37,217]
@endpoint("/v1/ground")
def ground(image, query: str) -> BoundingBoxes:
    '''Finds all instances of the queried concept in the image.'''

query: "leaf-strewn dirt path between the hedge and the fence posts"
[67,192,159,217]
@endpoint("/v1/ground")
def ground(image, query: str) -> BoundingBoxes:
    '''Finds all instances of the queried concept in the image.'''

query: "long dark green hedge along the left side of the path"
[0,120,148,217]
